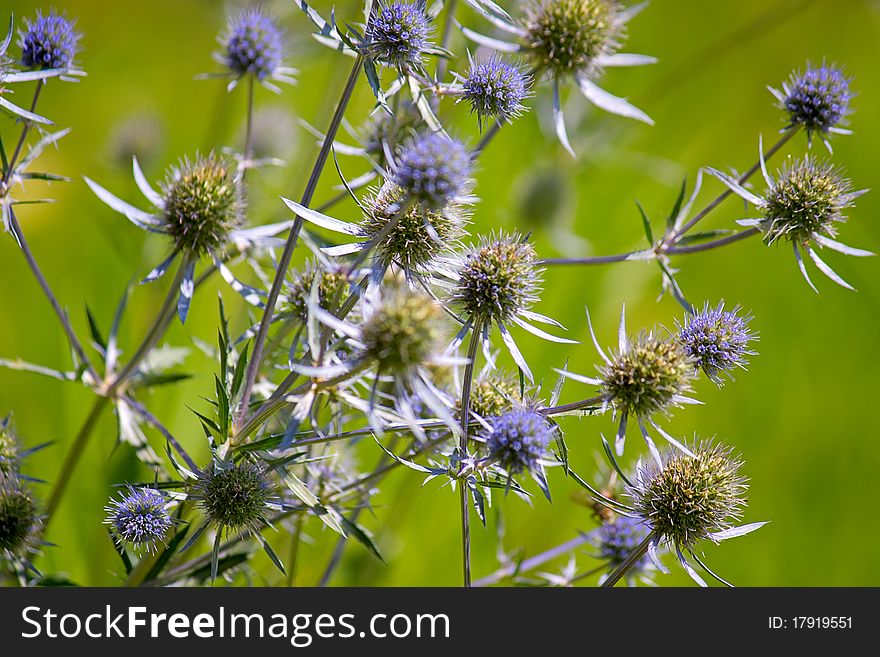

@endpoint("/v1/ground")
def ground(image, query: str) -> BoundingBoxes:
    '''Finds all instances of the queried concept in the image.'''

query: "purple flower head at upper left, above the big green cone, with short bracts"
[211,7,297,93]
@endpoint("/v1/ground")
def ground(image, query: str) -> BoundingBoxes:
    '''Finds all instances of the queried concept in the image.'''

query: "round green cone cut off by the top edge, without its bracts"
[524,0,621,78]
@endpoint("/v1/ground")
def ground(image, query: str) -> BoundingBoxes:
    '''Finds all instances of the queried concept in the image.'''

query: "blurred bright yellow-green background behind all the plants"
[0,0,880,586]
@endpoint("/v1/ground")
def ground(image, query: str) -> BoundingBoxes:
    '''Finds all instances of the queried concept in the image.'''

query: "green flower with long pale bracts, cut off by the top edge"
[462,0,656,157]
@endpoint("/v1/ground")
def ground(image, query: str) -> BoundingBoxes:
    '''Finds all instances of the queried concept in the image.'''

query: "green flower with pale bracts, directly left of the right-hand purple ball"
[557,306,700,463]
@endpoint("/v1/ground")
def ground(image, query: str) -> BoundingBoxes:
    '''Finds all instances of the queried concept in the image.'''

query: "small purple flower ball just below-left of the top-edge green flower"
[462,59,528,123]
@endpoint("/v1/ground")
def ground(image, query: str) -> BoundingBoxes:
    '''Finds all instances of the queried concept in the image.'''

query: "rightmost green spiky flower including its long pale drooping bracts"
[708,147,874,292]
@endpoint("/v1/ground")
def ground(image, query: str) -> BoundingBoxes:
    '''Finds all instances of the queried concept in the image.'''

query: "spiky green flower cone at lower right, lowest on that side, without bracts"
[630,442,748,548]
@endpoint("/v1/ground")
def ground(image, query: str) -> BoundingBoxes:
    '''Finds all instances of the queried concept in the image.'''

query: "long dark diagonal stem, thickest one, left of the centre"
[236,55,363,424]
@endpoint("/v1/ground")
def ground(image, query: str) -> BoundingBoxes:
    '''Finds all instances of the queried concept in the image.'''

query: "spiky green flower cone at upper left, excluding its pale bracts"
[162,153,241,255]
